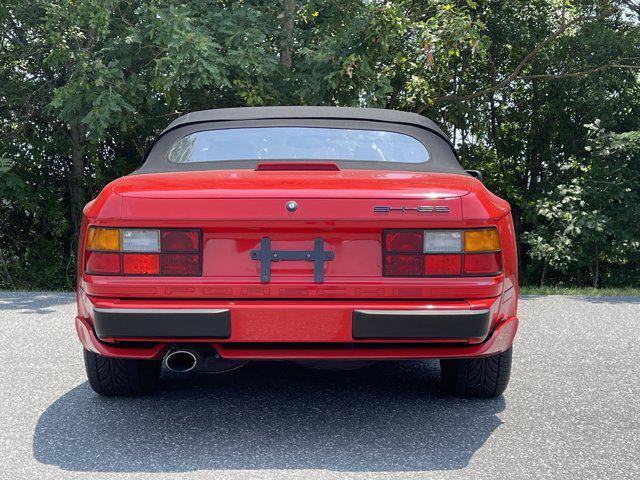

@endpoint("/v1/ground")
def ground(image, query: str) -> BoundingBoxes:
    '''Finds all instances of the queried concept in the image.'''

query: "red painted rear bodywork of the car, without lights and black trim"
[76,170,518,359]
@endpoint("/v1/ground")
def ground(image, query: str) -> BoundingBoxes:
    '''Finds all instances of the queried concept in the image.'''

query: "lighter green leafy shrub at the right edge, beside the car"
[525,126,640,287]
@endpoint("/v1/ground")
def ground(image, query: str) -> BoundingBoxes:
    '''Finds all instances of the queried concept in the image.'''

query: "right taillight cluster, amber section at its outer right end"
[382,228,502,277]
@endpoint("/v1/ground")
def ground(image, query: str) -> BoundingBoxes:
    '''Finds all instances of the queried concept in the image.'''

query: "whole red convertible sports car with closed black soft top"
[75,107,518,397]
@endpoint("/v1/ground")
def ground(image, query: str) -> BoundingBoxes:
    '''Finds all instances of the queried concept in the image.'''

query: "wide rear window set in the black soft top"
[168,127,429,163]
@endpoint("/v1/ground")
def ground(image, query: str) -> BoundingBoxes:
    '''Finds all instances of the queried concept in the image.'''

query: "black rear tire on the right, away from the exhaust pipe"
[440,348,512,398]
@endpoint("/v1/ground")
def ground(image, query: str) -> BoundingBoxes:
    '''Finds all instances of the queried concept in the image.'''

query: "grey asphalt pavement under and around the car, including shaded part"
[0,292,640,480]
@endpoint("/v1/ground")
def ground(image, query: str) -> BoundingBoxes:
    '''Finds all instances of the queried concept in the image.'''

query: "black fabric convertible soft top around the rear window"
[134,106,466,174]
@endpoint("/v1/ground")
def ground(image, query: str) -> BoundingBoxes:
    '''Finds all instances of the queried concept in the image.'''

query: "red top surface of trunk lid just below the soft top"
[114,170,472,199]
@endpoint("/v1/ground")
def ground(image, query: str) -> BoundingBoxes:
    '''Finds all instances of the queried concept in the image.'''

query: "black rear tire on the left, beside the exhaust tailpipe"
[84,350,161,397]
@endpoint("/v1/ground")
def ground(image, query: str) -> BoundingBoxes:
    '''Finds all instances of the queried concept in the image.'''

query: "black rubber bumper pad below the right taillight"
[352,310,490,340]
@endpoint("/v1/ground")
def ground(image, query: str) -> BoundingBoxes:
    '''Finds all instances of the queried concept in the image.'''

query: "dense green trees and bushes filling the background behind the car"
[0,0,640,289]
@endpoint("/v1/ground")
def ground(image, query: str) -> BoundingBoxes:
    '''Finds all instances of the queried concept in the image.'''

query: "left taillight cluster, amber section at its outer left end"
[85,227,202,276]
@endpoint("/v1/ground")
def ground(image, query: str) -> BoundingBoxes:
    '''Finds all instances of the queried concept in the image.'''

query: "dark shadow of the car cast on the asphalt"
[33,362,505,472]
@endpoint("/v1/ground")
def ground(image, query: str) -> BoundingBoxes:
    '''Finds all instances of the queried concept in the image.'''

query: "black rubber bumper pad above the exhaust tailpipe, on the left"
[93,309,231,338]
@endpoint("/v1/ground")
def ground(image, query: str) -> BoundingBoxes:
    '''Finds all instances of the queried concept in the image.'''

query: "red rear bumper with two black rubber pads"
[76,291,517,359]
